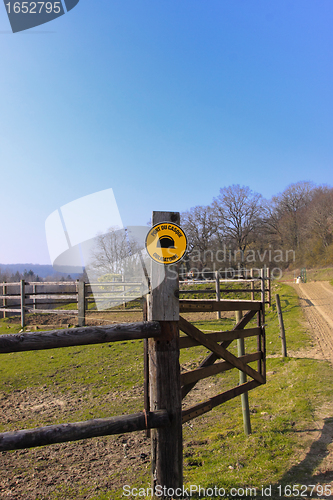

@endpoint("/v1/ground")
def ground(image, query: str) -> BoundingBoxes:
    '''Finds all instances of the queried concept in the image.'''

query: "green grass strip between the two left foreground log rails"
[0,340,143,395]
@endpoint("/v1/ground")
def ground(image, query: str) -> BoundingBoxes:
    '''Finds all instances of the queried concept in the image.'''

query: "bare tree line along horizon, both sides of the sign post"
[0,182,333,282]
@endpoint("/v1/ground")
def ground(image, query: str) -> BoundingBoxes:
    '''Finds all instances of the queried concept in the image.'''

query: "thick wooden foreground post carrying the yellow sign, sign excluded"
[148,212,183,492]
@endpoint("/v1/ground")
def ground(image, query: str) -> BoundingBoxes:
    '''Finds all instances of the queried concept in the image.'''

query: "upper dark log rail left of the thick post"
[0,321,161,353]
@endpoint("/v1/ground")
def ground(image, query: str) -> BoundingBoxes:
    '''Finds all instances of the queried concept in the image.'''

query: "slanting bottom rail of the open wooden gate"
[182,380,260,424]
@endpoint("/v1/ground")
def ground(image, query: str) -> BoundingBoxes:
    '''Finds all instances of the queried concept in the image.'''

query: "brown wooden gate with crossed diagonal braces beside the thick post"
[179,300,266,423]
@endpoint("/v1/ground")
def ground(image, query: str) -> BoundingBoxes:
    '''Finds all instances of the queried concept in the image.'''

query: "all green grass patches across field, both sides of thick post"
[0,285,333,500]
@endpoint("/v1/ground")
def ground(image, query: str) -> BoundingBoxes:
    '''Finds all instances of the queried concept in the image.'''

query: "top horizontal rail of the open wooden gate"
[179,298,262,313]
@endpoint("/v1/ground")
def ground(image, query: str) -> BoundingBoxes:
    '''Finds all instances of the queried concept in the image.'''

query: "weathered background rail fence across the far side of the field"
[0,268,271,328]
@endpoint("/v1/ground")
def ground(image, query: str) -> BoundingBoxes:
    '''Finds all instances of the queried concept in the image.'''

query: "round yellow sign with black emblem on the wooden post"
[146,222,187,264]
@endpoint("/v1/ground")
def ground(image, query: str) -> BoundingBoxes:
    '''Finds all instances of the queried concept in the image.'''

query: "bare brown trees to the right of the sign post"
[181,182,333,271]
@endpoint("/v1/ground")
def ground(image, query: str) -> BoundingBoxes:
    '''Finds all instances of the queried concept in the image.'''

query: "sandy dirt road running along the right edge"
[294,281,333,364]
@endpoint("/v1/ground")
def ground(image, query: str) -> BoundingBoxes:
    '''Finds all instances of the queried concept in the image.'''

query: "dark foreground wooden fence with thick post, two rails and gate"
[0,212,266,489]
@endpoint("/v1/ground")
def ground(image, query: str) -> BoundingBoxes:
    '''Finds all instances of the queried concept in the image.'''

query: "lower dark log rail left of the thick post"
[0,410,170,451]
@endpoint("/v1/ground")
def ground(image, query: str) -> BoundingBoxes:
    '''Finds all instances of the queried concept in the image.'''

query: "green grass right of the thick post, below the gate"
[179,359,332,498]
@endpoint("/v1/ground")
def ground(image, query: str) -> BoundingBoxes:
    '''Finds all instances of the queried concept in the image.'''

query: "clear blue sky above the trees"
[0,0,333,264]
